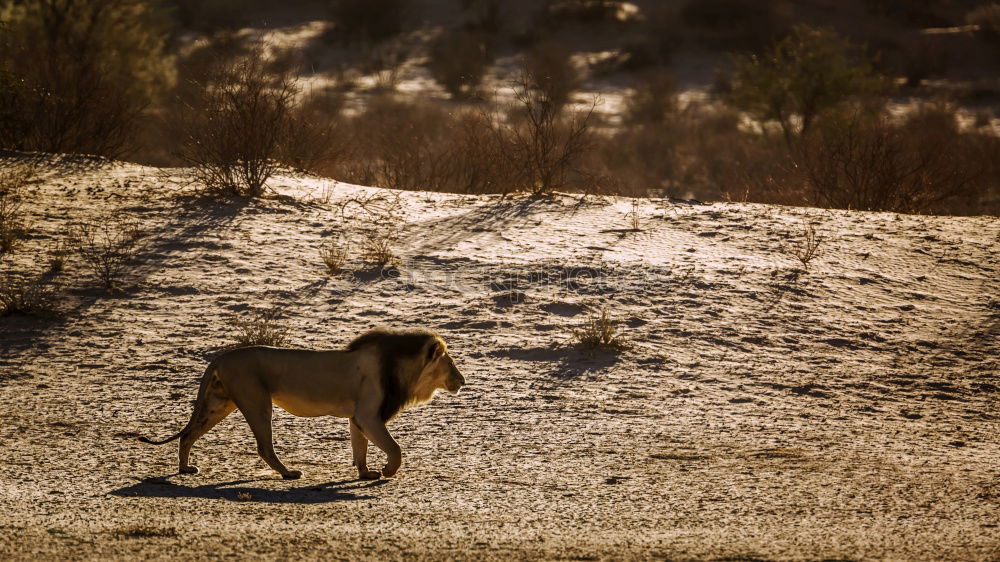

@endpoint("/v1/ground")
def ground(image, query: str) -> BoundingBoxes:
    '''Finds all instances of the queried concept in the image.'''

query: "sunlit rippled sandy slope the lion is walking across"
[0,155,1000,560]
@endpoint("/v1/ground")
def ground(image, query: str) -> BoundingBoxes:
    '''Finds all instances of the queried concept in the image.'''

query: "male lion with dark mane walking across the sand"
[140,329,465,480]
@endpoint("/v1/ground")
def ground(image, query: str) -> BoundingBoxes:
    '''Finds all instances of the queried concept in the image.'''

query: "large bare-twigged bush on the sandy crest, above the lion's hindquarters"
[171,49,298,197]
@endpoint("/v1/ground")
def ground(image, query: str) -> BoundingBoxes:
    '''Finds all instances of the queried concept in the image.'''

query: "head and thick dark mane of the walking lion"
[347,328,465,421]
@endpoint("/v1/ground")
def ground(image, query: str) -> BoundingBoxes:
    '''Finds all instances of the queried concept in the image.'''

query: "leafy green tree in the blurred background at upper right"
[728,25,888,148]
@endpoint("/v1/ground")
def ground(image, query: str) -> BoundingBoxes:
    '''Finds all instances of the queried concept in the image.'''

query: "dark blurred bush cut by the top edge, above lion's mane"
[327,0,410,44]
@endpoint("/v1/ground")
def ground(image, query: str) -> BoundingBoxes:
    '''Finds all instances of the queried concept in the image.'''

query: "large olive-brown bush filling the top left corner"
[0,0,173,157]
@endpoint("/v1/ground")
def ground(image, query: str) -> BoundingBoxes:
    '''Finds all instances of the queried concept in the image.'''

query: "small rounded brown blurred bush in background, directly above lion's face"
[427,29,493,98]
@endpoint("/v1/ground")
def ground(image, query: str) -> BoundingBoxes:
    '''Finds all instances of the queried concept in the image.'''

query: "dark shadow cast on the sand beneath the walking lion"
[109,474,387,504]
